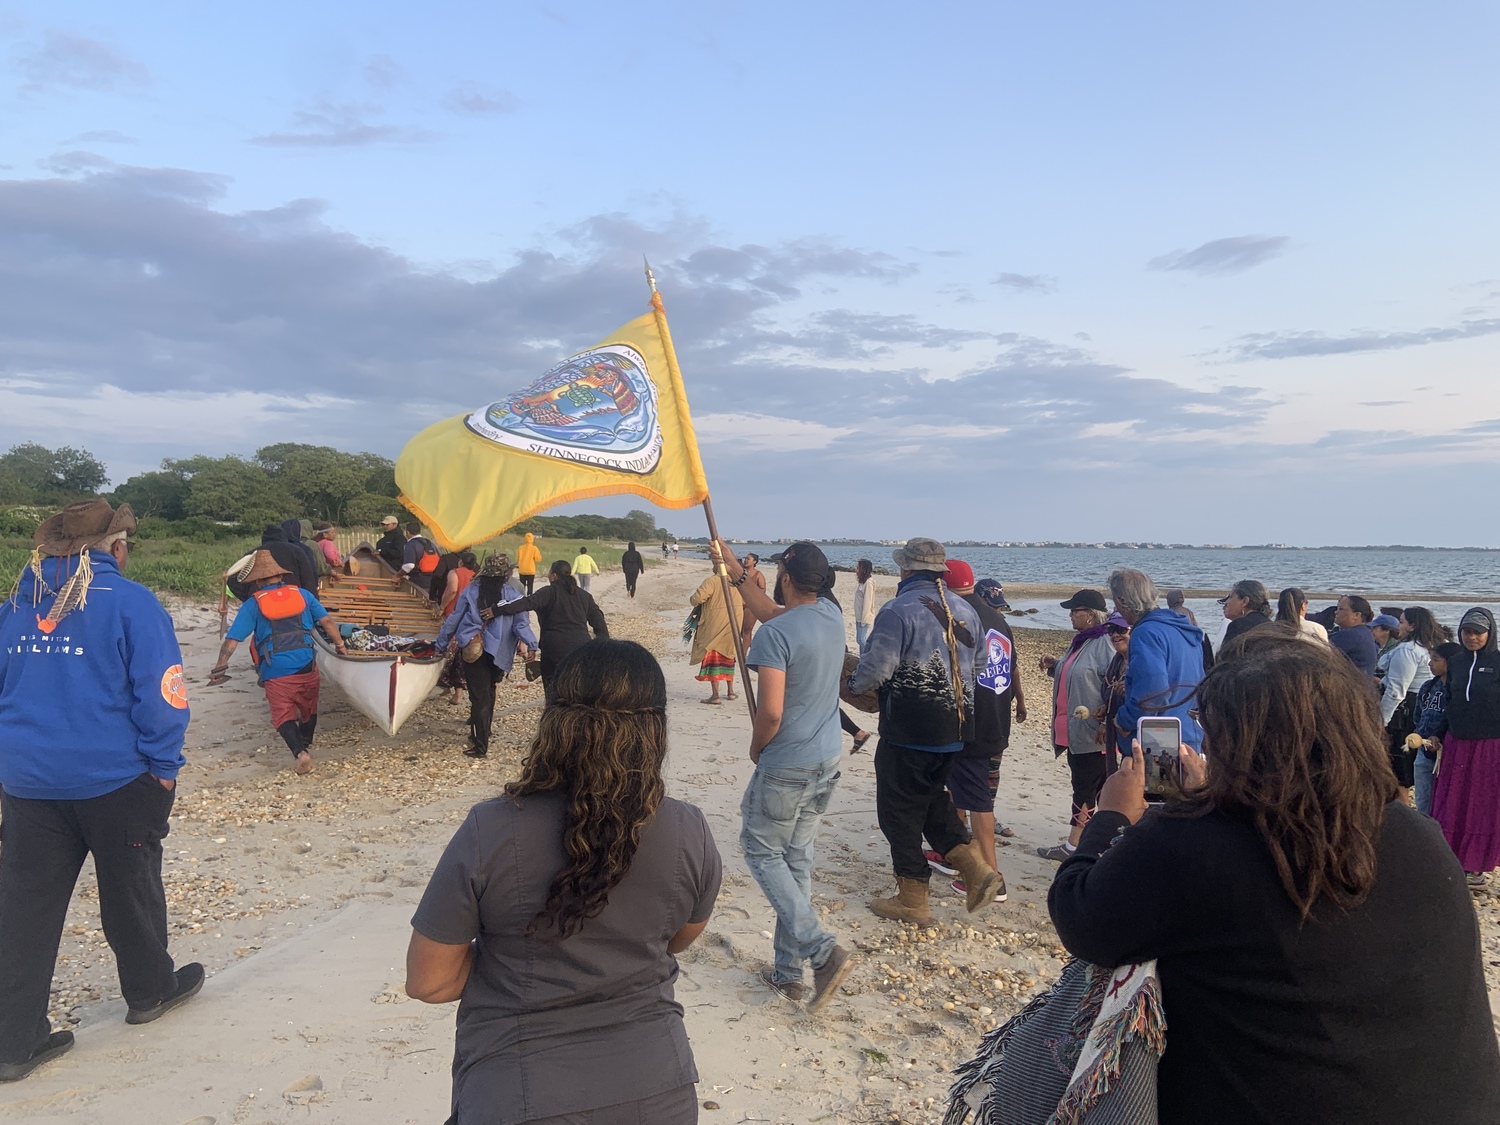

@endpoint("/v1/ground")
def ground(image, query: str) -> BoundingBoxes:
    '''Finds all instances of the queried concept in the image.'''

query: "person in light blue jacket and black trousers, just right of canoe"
[435,555,537,758]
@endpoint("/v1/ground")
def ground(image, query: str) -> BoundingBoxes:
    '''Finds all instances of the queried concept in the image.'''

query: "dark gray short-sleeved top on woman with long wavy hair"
[411,794,723,1125]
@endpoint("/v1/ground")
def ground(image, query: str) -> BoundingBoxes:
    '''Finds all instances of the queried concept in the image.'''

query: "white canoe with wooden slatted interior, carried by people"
[315,564,444,735]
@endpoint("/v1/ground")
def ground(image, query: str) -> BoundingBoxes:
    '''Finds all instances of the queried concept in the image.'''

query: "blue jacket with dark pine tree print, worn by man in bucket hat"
[849,570,984,753]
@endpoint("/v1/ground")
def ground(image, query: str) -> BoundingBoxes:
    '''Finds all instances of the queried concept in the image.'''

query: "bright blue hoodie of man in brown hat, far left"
[0,551,188,801]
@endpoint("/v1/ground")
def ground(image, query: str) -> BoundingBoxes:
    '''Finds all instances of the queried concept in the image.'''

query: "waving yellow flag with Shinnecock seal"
[396,293,708,551]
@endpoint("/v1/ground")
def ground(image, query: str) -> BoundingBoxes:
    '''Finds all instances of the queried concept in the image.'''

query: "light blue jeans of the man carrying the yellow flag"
[740,758,839,983]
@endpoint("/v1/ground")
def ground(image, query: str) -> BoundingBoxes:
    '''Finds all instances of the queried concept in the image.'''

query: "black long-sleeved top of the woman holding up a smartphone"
[1047,803,1500,1125]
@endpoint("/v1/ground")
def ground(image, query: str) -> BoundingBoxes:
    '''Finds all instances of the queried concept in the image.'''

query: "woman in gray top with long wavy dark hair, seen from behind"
[407,641,722,1125]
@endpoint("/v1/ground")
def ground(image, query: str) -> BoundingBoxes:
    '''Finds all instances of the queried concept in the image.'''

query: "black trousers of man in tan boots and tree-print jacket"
[875,738,969,882]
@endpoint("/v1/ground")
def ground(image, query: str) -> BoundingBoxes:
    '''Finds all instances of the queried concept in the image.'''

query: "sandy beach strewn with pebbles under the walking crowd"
[0,558,1500,1125]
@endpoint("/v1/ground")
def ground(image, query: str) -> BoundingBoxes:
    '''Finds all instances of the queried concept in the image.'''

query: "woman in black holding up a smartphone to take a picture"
[1049,630,1500,1125]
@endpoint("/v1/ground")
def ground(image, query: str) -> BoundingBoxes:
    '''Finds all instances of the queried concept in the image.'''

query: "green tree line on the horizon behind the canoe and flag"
[0,443,671,543]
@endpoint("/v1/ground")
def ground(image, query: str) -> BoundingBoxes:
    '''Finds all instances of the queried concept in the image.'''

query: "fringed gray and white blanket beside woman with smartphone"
[944,962,1167,1125]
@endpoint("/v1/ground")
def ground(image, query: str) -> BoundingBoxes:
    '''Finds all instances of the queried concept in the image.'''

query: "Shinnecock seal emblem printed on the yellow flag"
[464,344,662,474]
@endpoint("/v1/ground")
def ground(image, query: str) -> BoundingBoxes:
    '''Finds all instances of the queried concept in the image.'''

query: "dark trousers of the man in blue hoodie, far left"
[0,774,177,1062]
